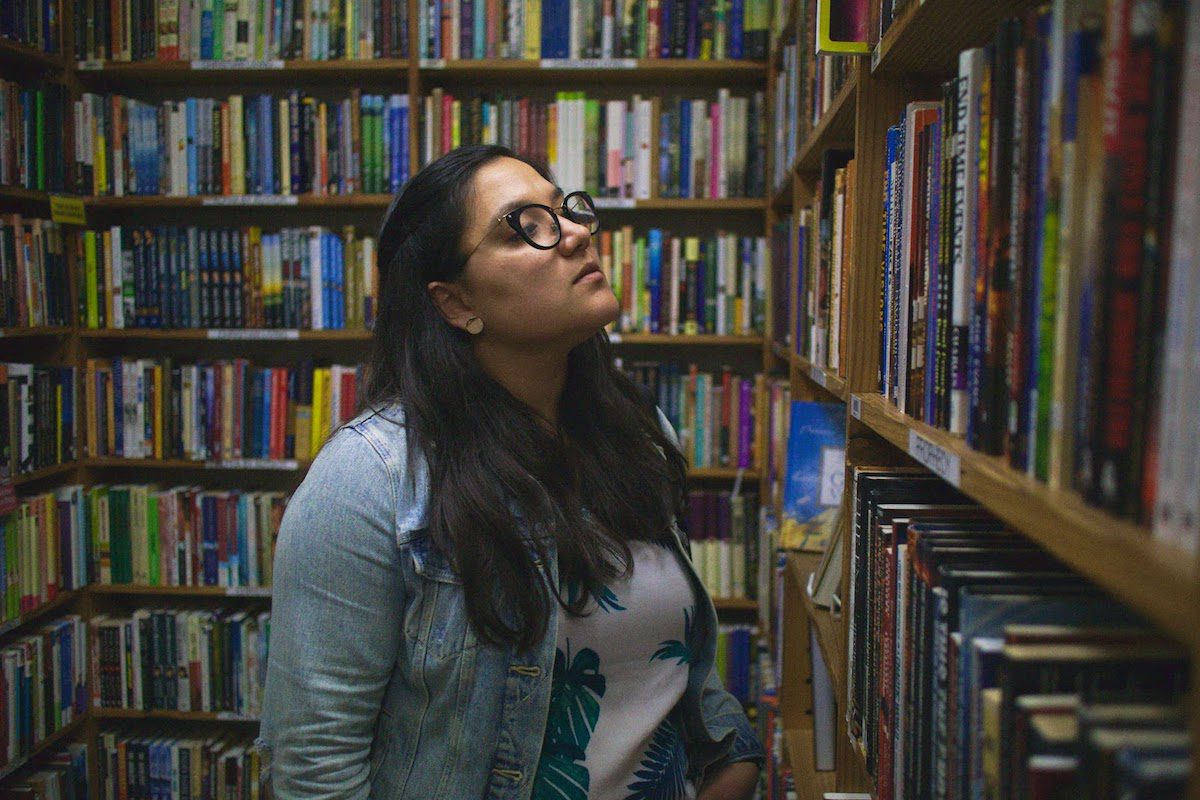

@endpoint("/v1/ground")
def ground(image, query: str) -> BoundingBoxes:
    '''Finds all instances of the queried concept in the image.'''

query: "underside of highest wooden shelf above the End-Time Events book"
[871,0,1038,79]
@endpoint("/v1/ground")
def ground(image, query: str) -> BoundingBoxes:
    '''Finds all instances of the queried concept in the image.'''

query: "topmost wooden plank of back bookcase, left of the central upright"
[76,59,408,85]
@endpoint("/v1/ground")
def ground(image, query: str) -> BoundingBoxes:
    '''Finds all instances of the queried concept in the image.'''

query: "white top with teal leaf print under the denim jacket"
[533,542,696,800]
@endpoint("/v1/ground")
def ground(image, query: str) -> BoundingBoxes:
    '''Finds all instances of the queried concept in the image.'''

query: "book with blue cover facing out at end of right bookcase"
[780,401,846,551]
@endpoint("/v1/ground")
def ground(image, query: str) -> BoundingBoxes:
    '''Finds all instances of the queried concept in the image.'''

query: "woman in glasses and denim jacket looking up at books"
[260,146,762,800]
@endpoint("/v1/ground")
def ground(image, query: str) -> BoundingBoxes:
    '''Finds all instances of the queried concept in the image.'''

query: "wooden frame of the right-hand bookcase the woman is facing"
[768,0,1200,800]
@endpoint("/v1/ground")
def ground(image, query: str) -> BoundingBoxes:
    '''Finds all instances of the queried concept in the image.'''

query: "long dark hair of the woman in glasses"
[364,145,685,650]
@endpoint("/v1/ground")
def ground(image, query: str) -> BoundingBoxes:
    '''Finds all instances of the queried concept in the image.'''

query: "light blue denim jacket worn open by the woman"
[258,408,762,800]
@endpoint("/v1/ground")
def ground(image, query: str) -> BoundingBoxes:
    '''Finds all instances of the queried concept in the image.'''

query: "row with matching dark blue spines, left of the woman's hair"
[76,225,378,331]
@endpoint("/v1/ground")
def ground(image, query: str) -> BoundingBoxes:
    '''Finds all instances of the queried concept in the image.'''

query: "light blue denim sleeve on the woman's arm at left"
[258,428,404,800]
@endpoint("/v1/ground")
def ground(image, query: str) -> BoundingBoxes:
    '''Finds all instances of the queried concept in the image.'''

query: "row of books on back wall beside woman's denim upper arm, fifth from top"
[90,483,287,588]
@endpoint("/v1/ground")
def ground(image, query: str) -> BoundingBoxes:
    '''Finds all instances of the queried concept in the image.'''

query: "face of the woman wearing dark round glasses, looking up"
[457,158,619,349]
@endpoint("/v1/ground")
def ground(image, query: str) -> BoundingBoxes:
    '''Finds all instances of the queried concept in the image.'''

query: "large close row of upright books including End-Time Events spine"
[880,0,1200,519]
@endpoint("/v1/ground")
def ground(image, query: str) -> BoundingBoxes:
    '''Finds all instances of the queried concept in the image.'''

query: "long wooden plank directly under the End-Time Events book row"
[851,395,1200,645]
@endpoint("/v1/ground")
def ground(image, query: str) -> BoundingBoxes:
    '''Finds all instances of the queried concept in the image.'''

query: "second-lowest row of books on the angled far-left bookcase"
[0,614,88,764]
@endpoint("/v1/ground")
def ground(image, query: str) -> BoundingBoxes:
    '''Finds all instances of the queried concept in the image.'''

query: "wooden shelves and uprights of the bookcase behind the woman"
[0,0,768,792]
